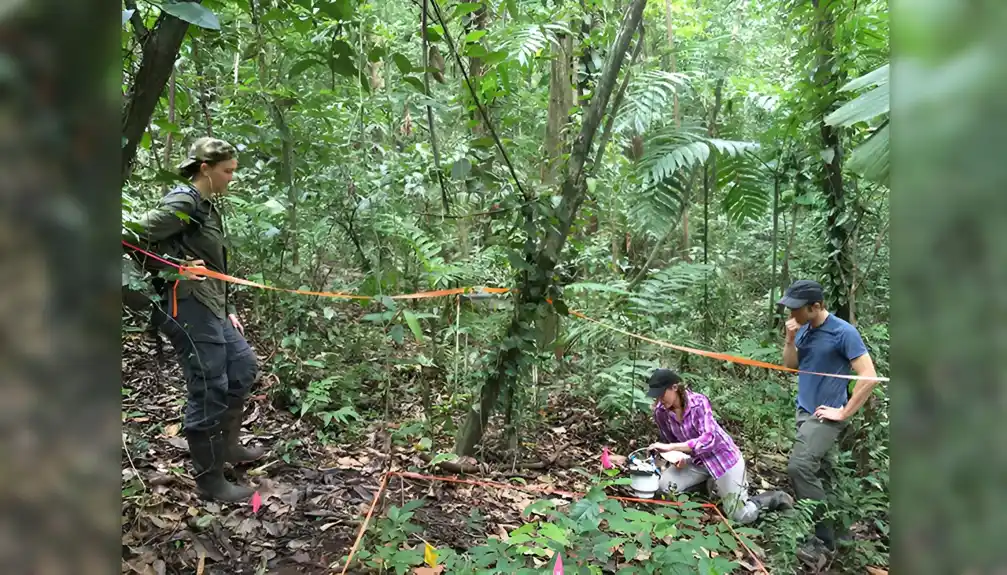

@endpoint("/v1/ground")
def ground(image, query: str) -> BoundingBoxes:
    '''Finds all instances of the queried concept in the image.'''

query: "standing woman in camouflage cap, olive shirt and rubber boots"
[127,138,265,501]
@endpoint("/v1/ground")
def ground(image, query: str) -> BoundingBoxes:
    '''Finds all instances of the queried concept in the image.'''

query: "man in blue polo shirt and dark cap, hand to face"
[777,280,877,568]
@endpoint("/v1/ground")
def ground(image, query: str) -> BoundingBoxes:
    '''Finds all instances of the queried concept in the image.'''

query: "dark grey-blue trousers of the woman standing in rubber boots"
[154,297,259,431]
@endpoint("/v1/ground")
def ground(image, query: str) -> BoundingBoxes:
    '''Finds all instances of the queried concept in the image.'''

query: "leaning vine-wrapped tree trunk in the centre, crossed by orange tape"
[455,0,646,455]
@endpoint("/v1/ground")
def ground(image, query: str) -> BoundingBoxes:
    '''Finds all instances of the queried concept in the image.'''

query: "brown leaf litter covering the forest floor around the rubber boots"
[122,314,861,575]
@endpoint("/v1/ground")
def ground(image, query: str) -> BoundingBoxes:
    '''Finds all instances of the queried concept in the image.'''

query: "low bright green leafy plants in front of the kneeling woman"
[357,479,758,575]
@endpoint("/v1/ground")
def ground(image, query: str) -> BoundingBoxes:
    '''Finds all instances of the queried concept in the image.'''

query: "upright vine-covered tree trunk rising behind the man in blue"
[813,0,852,321]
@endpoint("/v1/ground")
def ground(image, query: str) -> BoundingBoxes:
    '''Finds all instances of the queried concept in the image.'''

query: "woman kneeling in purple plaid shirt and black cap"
[646,370,794,524]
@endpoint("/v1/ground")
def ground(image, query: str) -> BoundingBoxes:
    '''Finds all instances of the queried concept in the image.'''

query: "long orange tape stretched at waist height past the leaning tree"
[123,241,889,382]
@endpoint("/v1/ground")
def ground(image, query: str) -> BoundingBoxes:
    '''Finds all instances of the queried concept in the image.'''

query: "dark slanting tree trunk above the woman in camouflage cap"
[121,6,201,181]
